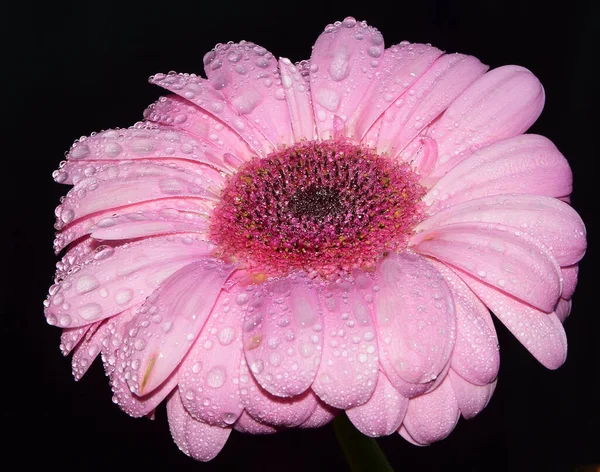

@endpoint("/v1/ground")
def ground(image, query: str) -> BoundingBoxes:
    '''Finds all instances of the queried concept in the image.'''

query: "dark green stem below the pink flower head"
[333,413,394,472]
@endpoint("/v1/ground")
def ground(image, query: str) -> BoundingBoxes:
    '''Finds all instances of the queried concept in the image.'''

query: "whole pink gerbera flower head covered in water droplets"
[45,18,586,461]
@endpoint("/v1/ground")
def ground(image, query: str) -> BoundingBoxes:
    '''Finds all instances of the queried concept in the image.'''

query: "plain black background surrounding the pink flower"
[0,0,600,472]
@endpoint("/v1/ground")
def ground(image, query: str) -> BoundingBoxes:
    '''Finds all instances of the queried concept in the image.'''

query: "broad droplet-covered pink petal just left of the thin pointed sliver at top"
[204,41,293,148]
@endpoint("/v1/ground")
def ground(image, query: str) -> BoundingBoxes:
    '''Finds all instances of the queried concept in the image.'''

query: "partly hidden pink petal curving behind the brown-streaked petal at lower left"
[102,307,177,418]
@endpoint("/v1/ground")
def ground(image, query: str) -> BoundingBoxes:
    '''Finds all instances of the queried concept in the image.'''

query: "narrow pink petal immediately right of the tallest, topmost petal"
[349,41,442,139]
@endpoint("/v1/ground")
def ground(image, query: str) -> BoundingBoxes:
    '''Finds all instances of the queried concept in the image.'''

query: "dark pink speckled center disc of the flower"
[211,141,424,275]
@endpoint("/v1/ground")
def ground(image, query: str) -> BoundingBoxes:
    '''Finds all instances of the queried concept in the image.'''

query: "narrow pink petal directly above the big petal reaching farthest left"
[54,198,214,252]
